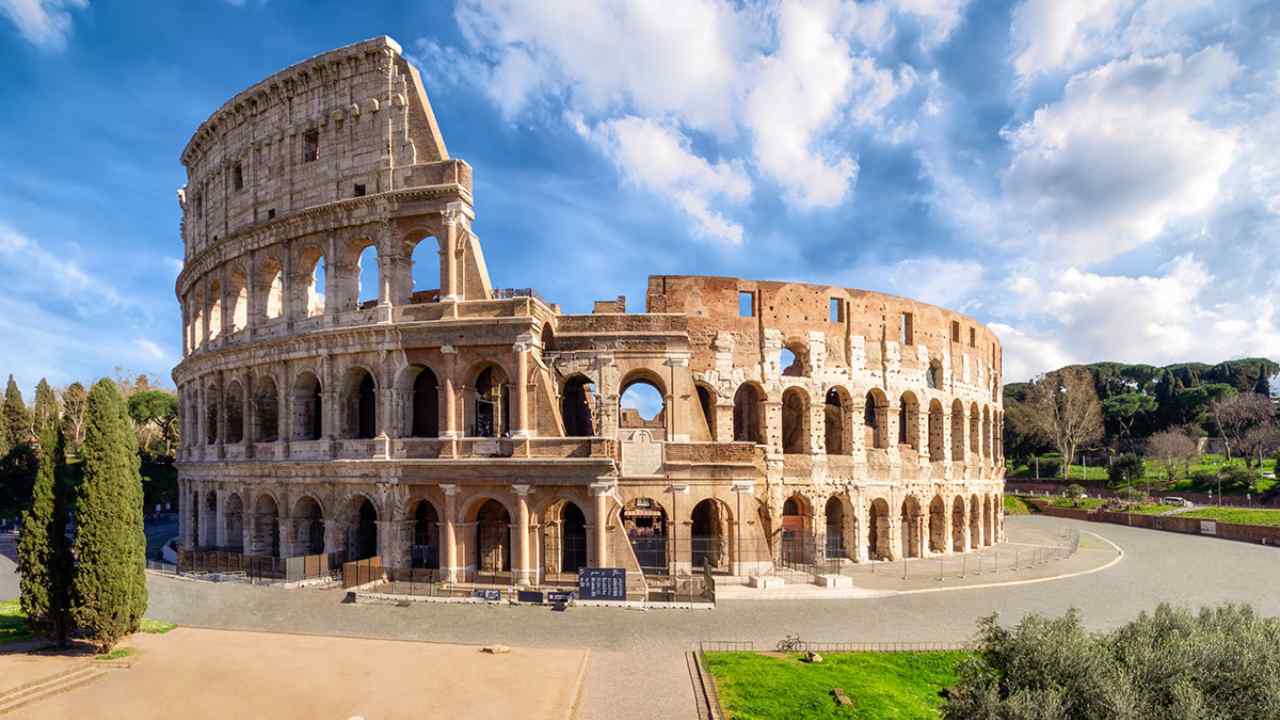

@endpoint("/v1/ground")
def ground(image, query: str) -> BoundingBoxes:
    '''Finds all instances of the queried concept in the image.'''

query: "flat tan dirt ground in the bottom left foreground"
[0,628,588,720]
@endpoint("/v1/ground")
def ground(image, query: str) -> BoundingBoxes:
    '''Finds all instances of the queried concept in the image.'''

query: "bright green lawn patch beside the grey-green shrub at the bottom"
[707,651,969,720]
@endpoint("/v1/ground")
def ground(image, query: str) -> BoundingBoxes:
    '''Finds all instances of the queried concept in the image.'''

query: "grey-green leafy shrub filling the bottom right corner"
[943,605,1280,720]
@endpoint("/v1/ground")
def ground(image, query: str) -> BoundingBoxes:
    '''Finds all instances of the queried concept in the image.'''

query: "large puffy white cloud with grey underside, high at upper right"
[1002,46,1239,264]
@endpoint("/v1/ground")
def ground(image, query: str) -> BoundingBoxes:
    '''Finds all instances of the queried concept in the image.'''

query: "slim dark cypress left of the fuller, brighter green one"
[18,415,72,647]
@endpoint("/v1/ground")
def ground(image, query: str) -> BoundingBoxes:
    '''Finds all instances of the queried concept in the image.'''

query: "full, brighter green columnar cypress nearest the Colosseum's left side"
[72,379,147,652]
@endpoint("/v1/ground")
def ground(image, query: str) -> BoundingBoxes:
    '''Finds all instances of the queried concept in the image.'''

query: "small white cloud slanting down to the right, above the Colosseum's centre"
[571,115,751,245]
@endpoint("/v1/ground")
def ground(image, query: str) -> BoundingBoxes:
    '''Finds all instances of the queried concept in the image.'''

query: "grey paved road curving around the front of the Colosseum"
[0,516,1280,720]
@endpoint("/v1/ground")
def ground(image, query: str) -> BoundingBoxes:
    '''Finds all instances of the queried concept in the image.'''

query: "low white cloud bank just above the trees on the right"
[993,255,1280,380]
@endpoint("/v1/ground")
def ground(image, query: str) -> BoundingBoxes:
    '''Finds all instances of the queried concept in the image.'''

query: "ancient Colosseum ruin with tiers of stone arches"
[173,37,1004,587]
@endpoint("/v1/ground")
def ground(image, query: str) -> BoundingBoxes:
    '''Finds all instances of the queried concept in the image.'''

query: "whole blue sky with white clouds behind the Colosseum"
[0,0,1280,388]
